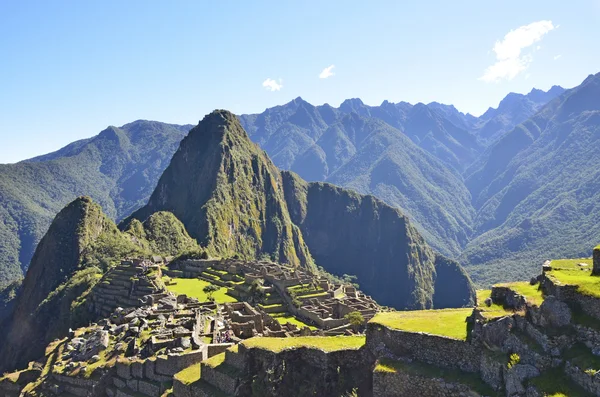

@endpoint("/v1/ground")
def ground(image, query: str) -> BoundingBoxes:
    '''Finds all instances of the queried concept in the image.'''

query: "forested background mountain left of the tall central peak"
[0,120,189,289]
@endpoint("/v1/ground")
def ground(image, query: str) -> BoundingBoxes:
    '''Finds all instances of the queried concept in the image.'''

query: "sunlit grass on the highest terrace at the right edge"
[546,259,600,298]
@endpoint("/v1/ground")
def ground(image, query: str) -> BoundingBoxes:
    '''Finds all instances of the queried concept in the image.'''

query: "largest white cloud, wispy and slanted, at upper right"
[479,21,555,83]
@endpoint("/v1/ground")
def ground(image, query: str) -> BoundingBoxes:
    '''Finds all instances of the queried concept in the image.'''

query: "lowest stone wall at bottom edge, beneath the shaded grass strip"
[373,371,479,397]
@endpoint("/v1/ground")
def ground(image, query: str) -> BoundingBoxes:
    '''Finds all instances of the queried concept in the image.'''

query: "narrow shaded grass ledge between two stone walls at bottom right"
[374,358,499,396]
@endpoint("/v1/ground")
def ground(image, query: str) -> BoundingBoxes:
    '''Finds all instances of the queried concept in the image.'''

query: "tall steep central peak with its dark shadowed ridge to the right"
[129,110,473,308]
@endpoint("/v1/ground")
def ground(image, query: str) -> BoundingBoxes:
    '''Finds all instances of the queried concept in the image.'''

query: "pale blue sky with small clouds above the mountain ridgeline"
[0,0,600,163]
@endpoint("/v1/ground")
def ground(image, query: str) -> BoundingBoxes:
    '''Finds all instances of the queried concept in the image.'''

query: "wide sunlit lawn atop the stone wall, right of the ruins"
[369,308,473,340]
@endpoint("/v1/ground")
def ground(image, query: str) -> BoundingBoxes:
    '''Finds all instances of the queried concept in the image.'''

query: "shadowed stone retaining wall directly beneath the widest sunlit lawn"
[367,323,482,372]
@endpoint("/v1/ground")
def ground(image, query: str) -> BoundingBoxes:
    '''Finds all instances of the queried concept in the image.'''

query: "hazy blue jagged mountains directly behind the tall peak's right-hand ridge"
[240,98,482,256]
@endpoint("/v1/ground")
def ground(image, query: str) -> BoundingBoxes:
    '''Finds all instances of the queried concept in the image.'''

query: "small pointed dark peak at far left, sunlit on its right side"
[0,197,142,370]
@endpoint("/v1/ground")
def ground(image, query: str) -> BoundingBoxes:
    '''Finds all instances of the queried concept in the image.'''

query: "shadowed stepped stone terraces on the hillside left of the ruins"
[92,261,159,317]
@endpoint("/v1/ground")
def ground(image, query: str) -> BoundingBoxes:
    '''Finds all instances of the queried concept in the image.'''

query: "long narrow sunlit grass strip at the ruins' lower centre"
[242,336,365,353]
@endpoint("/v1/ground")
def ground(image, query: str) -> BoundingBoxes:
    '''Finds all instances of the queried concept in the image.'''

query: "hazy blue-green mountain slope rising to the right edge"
[465,74,600,282]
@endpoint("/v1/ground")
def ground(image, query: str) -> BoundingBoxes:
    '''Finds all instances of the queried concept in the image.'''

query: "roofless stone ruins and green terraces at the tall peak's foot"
[164,259,380,335]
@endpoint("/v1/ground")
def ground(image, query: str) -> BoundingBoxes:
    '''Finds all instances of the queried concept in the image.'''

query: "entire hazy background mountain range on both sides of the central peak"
[0,75,600,296]
